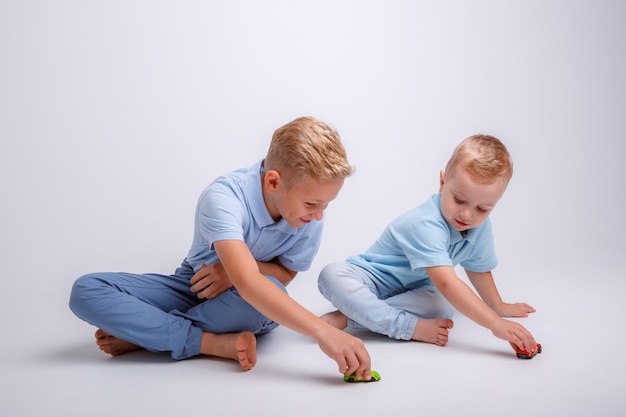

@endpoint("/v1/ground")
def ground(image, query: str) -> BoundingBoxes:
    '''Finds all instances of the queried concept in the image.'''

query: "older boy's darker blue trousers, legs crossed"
[70,261,287,359]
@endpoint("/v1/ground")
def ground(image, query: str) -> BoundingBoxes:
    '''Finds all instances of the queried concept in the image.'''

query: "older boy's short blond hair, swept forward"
[265,117,354,186]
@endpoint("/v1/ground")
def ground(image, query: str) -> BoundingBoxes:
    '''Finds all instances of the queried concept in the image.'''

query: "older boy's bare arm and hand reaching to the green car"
[214,240,371,379]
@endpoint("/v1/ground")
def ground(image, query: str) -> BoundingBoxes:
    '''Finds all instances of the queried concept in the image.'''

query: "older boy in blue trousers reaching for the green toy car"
[70,117,370,379]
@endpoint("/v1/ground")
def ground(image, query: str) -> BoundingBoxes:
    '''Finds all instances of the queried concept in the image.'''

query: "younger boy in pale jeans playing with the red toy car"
[319,135,537,353]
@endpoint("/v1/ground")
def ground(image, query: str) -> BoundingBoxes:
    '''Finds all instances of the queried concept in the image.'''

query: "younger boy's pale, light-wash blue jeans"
[318,262,455,340]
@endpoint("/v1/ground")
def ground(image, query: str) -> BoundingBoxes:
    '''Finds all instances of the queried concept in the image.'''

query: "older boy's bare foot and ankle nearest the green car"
[200,331,256,371]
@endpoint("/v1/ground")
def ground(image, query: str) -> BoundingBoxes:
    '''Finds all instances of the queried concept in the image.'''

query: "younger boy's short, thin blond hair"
[446,134,513,183]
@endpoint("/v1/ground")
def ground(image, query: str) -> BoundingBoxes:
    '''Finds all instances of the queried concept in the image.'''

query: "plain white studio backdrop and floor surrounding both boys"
[0,0,626,416]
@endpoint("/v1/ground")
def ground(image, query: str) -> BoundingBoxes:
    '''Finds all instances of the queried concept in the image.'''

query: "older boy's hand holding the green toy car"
[319,326,372,380]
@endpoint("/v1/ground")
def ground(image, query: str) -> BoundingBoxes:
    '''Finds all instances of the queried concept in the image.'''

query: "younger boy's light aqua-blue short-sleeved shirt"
[348,194,498,289]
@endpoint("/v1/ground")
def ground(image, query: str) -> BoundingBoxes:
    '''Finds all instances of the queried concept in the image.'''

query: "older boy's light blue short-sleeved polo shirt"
[187,161,323,271]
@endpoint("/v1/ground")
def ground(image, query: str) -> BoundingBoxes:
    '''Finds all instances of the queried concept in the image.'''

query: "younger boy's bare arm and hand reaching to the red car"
[426,266,537,351]
